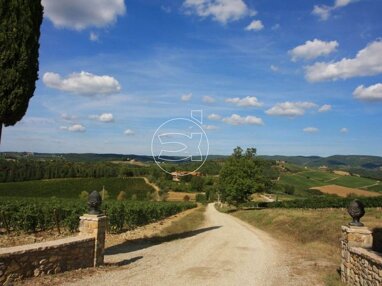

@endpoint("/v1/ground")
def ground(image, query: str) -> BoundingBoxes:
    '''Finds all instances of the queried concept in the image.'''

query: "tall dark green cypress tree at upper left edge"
[0,0,43,140]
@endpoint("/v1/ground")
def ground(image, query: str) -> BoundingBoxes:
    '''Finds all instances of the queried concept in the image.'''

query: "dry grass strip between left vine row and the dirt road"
[156,205,206,238]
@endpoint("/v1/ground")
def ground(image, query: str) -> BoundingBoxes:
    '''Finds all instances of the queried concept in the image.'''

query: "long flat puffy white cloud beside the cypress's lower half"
[42,71,121,95]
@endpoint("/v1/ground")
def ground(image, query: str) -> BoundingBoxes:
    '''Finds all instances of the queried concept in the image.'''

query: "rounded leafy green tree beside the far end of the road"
[219,147,264,206]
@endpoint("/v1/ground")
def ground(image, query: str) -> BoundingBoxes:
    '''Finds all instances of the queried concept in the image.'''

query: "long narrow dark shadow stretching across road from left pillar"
[105,226,221,255]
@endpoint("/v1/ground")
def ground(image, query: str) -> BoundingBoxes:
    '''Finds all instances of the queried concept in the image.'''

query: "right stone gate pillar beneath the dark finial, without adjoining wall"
[341,225,373,283]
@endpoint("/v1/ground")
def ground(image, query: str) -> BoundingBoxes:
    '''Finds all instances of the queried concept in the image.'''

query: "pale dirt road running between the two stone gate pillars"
[66,204,311,286]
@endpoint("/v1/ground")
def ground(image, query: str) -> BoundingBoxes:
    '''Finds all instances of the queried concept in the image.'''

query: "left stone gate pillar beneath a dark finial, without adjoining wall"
[79,214,106,267]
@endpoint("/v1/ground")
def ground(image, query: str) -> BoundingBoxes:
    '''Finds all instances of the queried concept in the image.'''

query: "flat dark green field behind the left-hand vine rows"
[0,178,155,200]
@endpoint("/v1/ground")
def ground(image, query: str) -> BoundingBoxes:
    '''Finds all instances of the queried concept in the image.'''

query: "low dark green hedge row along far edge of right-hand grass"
[242,196,382,209]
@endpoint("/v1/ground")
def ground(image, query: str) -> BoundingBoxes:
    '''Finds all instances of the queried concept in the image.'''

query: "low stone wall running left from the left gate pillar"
[0,236,95,285]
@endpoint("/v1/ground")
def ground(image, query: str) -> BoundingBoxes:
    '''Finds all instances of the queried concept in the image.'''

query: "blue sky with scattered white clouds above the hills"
[1,0,382,156]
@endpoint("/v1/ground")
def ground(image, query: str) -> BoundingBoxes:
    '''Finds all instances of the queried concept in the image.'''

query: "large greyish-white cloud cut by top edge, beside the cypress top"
[42,0,126,31]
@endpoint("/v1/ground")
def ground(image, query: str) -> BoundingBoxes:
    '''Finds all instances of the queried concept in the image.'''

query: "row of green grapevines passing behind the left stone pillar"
[0,199,196,232]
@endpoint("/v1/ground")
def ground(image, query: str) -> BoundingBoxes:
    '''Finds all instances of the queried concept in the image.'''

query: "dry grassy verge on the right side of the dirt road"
[224,209,382,285]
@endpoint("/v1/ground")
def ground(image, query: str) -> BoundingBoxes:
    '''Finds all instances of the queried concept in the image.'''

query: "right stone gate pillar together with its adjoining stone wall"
[341,226,382,286]
